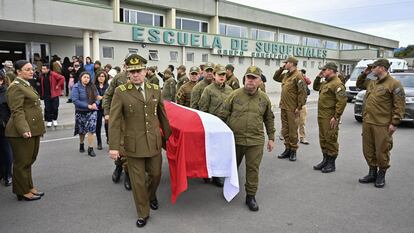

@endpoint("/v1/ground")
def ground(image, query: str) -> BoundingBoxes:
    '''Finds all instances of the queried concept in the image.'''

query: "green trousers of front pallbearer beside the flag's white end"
[236,145,263,196]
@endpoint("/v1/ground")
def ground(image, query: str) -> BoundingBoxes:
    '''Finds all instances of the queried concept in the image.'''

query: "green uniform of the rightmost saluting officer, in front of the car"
[356,74,405,170]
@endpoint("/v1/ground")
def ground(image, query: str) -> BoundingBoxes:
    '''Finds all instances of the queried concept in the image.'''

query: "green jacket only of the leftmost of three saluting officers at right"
[273,69,307,111]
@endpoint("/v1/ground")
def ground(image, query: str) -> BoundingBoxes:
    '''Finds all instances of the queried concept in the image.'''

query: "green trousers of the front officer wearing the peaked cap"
[128,154,162,218]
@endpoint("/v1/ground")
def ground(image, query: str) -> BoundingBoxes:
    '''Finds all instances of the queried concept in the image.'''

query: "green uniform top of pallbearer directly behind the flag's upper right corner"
[198,83,233,116]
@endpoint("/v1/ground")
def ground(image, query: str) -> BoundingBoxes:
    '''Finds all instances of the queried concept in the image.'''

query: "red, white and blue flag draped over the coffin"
[164,101,239,203]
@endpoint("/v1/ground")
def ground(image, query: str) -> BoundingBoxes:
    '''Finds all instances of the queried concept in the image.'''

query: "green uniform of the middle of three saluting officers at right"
[313,76,347,157]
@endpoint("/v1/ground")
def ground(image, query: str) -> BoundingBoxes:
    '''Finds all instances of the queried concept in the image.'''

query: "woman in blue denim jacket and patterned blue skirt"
[72,72,98,157]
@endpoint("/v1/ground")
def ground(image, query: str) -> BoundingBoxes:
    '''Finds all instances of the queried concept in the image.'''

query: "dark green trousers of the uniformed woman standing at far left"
[9,136,40,195]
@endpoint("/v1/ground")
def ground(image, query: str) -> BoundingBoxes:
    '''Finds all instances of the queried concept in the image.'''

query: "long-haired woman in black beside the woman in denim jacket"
[95,70,109,150]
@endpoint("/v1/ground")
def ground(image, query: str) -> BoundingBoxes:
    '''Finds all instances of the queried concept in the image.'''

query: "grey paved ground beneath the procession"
[0,98,414,233]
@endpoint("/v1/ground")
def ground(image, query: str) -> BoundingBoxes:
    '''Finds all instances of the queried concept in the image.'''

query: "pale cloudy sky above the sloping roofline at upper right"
[228,0,414,47]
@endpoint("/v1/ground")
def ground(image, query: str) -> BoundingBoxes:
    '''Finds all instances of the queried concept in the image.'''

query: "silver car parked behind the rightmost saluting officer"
[354,71,414,126]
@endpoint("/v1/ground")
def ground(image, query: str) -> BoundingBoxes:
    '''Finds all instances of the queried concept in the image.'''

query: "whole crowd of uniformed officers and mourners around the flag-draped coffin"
[0,53,405,227]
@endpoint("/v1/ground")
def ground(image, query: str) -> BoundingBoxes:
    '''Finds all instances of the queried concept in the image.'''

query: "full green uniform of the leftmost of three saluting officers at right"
[273,68,307,151]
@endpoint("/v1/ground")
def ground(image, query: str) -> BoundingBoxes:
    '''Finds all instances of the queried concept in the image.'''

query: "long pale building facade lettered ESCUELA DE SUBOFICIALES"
[0,0,398,91]
